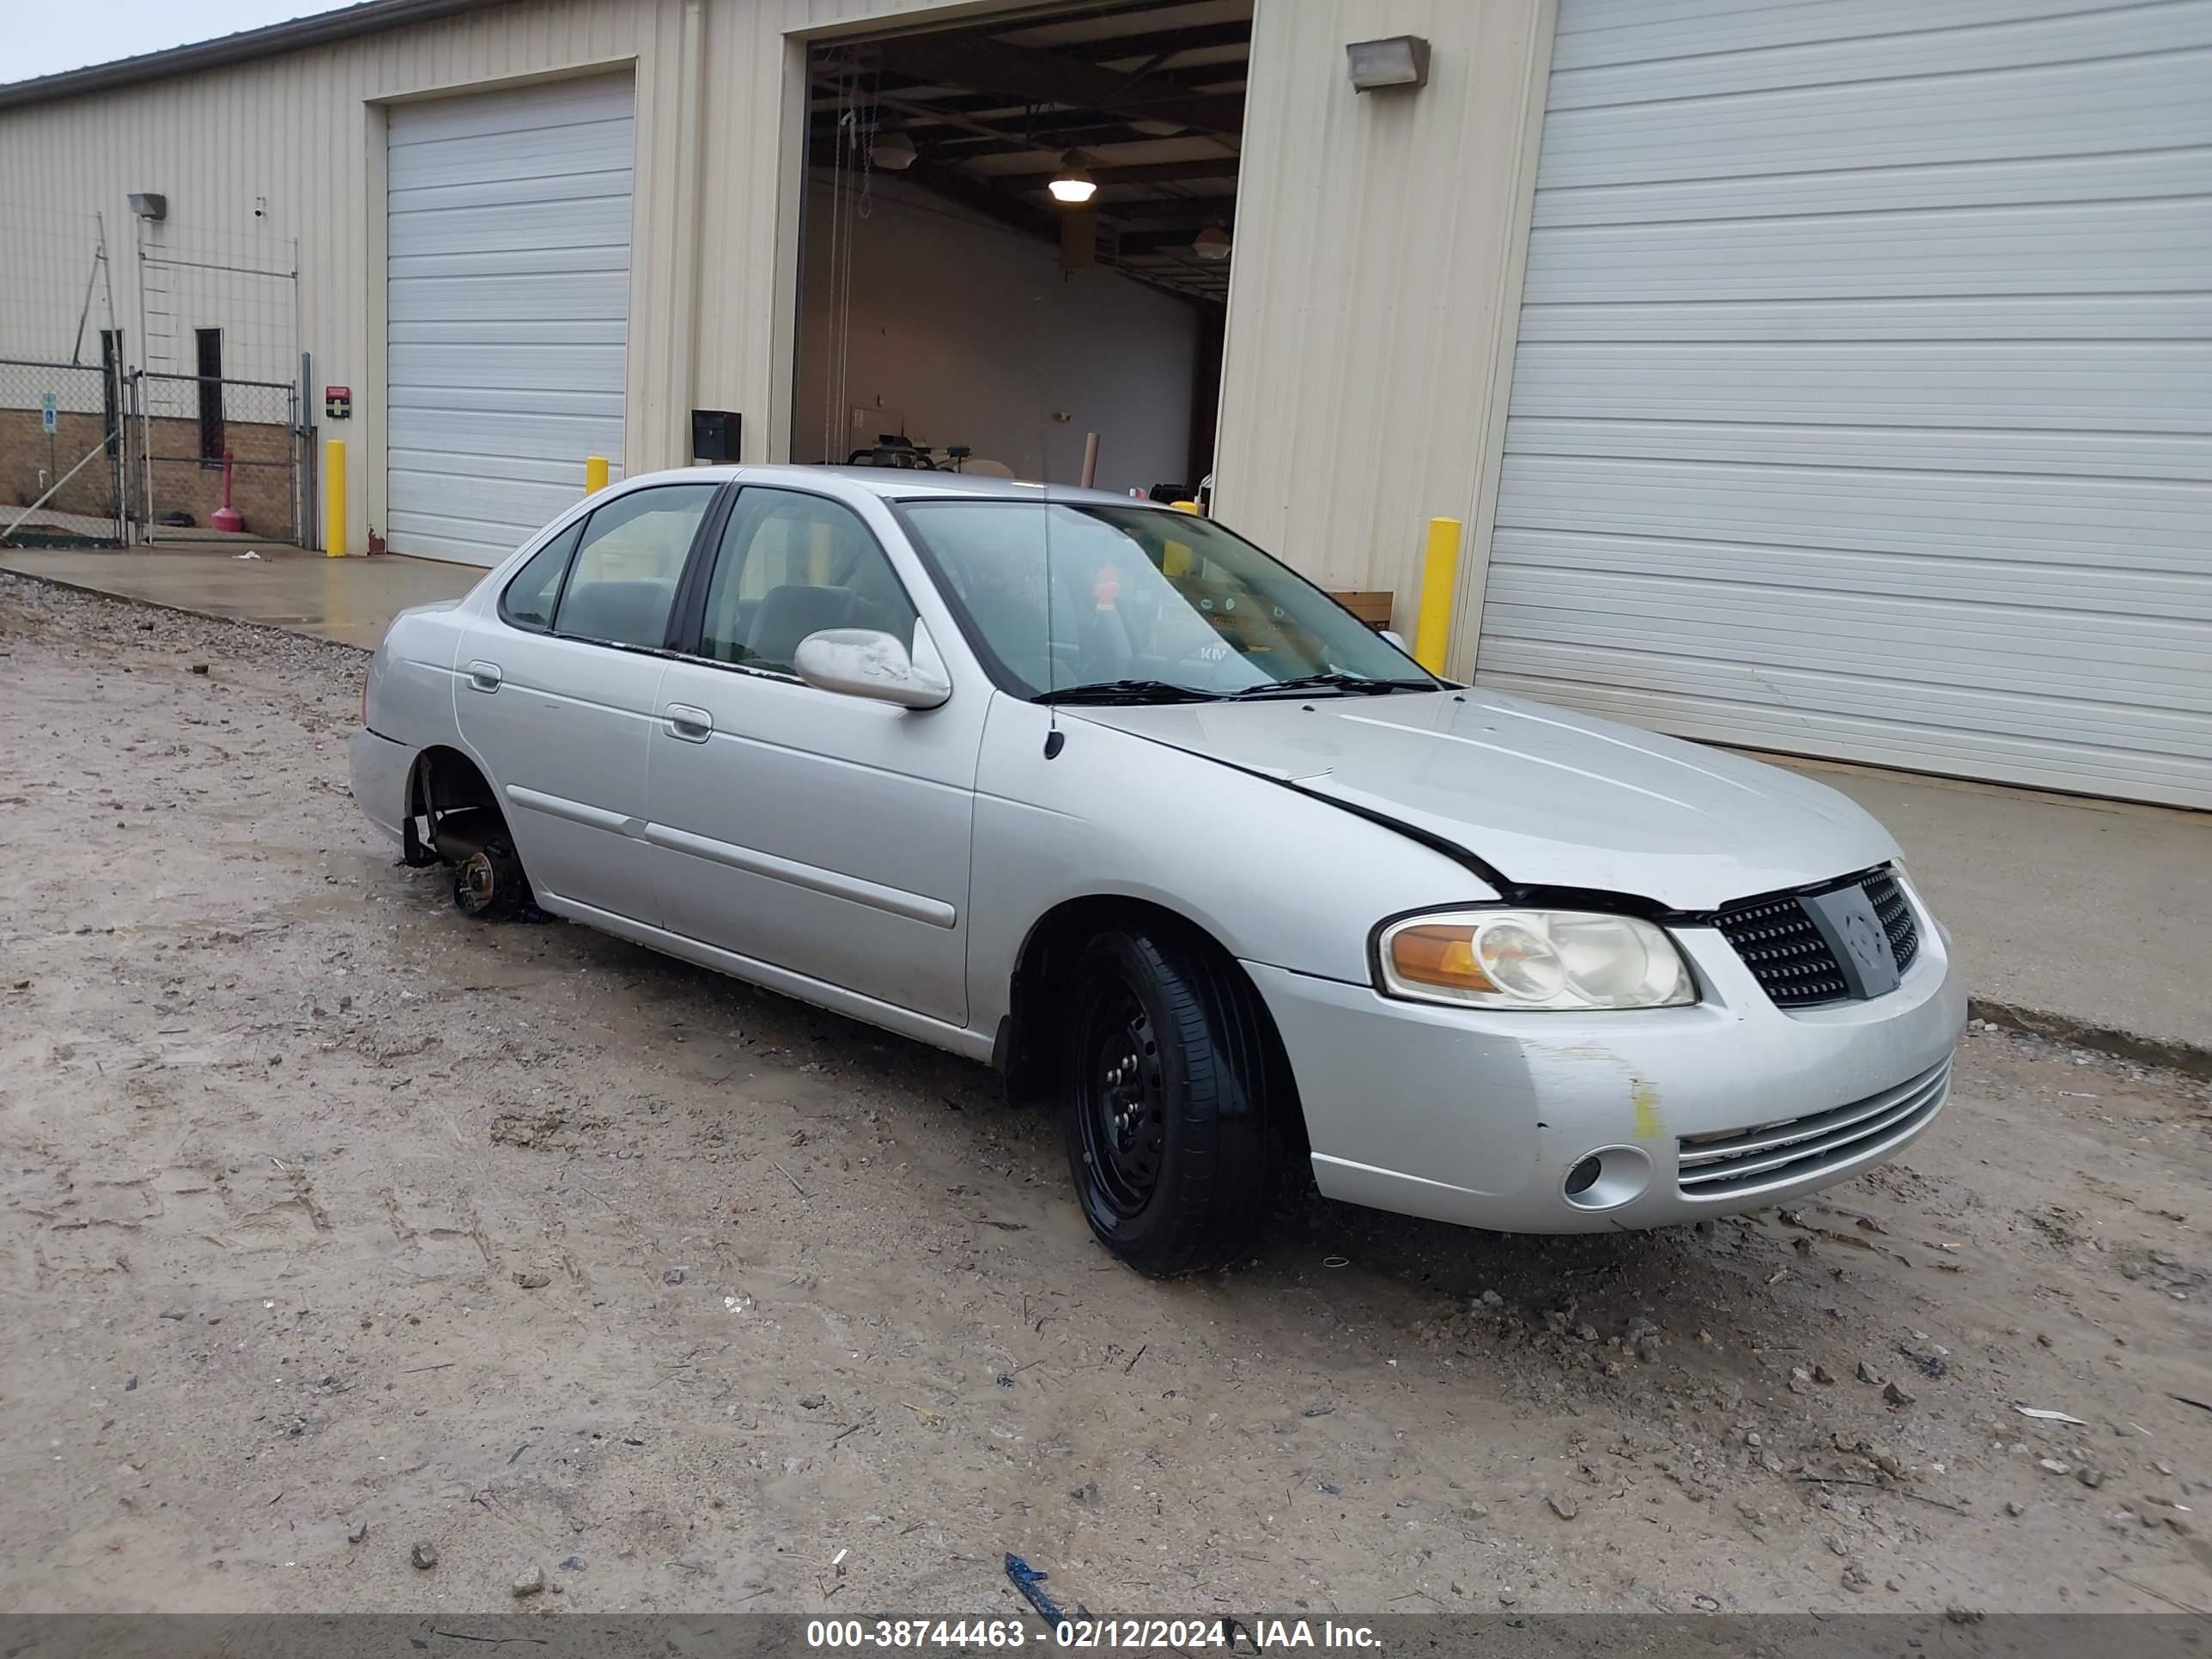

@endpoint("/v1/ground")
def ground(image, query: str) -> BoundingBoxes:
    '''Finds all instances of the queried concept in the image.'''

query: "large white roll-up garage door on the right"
[1478,0,2212,807]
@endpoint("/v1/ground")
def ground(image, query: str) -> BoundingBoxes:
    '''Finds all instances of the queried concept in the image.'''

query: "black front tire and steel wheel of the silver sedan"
[1060,929,1297,1279]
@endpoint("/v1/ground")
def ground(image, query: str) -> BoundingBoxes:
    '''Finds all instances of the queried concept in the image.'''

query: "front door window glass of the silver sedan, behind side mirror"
[699,487,914,675]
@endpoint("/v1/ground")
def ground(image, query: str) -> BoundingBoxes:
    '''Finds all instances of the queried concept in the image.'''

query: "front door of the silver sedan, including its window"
[650,484,988,1024]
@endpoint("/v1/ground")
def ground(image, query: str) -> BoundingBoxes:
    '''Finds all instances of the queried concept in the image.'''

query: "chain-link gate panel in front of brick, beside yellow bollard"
[131,369,307,542]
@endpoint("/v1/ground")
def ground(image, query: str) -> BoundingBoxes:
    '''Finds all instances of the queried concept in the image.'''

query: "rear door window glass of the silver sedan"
[500,484,719,648]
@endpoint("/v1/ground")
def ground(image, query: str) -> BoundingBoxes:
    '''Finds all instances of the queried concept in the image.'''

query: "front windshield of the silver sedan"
[905,500,1443,702]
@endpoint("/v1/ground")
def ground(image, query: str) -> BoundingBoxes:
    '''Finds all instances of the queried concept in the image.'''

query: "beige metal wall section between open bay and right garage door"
[1214,0,1548,617]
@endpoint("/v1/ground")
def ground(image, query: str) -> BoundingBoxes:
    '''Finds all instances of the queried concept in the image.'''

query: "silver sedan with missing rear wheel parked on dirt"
[352,467,1964,1274]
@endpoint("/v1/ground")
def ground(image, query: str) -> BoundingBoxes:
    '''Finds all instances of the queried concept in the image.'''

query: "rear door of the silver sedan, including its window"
[453,484,719,925]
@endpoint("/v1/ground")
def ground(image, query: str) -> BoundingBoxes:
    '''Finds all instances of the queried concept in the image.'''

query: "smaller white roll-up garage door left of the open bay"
[385,76,635,564]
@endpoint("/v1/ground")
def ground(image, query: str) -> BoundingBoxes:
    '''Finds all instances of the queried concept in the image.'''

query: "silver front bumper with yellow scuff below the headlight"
[1245,896,1966,1232]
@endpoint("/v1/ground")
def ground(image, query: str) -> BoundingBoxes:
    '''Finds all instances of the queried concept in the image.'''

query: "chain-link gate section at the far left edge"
[0,356,131,546]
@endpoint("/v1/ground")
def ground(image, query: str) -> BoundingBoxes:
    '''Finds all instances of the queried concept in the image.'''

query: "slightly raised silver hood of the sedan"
[1061,690,1898,911]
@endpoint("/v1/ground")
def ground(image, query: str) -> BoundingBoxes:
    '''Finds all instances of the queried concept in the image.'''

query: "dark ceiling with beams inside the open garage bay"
[810,0,1252,305]
